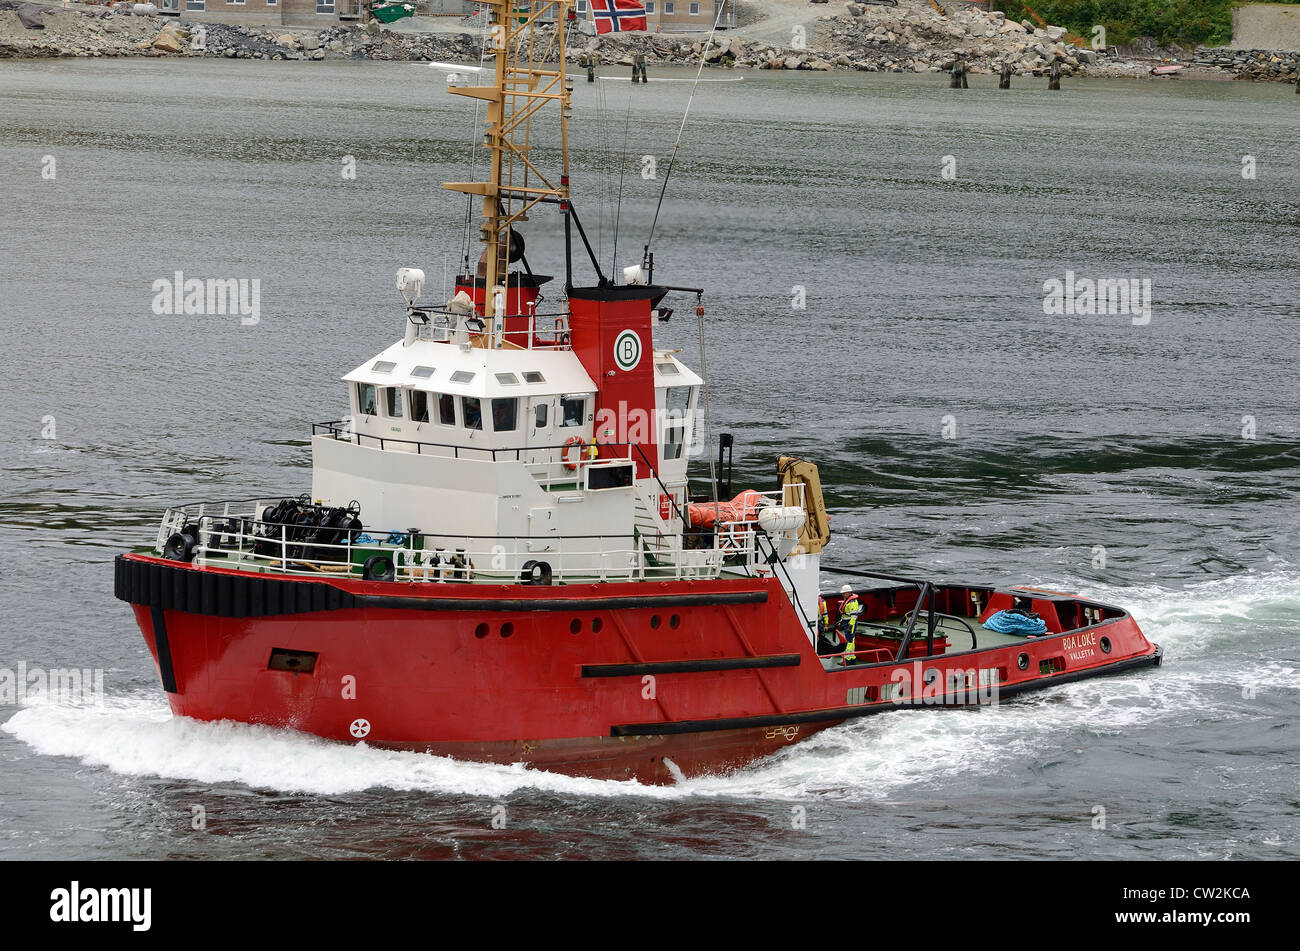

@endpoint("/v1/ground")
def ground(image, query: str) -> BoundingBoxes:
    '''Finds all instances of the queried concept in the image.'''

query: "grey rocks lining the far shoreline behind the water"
[0,0,1300,82]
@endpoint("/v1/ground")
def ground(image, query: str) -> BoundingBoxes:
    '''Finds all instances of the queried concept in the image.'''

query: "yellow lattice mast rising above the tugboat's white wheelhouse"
[442,0,572,302]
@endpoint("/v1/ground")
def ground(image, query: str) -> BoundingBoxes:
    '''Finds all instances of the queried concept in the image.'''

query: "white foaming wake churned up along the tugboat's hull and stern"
[3,576,1300,800]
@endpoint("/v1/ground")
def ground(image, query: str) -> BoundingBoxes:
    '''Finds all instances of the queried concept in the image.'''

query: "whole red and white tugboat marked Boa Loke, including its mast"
[116,0,1161,782]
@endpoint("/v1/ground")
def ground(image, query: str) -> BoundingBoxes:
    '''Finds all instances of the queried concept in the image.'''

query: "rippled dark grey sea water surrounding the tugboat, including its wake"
[0,61,1300,860]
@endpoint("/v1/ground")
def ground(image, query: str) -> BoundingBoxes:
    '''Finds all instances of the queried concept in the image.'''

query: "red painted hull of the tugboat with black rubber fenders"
[118,555,1160,782]
